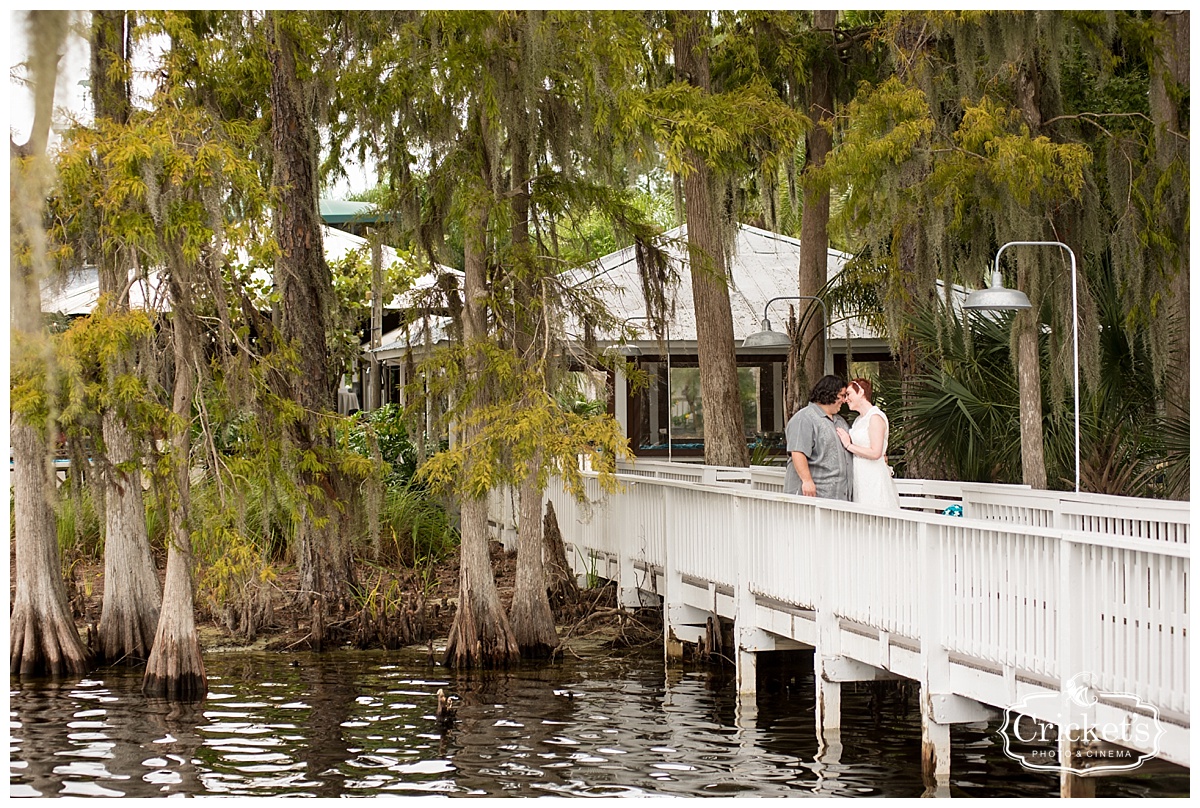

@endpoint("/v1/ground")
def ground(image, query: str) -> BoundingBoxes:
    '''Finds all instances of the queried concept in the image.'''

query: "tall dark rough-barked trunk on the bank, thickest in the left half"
[268,12,354,650]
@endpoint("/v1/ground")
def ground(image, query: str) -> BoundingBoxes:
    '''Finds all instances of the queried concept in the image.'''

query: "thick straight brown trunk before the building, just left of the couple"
[673,11,750,466]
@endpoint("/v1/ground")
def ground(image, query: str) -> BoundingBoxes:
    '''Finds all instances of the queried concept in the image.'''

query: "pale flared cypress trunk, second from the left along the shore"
[91,4,162,663]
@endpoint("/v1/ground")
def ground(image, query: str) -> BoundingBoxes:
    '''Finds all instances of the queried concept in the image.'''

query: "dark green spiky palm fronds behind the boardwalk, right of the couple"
[897,266,1190,498]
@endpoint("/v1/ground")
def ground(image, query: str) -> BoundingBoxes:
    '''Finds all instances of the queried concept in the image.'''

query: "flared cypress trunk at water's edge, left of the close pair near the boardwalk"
[445,157,520,668]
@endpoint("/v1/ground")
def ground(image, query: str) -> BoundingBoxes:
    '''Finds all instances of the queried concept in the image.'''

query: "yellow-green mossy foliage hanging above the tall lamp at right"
[828,11,1187,420]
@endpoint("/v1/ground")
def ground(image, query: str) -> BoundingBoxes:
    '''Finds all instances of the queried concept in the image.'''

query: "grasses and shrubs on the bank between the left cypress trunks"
[30,405,661,665]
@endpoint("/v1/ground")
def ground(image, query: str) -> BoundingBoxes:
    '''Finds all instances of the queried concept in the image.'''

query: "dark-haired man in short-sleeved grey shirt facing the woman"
[784,376,854,501]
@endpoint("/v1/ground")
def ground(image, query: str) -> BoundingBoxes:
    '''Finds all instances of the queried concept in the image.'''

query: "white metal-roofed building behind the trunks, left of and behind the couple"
[364,225,907,457]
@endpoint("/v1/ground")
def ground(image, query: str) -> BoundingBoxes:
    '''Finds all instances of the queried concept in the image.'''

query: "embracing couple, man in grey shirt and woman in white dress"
[784,376,900,509]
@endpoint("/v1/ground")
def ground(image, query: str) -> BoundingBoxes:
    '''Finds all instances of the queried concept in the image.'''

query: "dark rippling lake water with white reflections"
[8,652,1189,797]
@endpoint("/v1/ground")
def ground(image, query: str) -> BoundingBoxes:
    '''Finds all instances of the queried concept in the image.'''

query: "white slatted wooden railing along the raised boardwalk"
[492,461,1190,760]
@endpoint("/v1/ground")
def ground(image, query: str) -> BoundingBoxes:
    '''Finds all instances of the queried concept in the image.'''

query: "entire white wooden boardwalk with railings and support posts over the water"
[491,461,1190,794]
